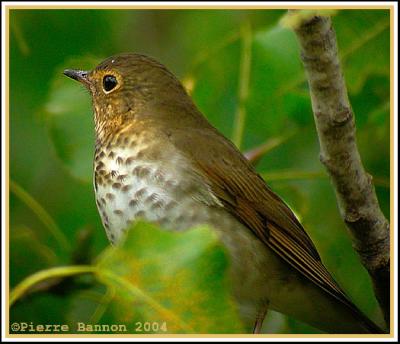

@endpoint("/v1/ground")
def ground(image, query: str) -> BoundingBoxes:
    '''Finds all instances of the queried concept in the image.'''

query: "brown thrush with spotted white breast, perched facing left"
[64,53,384,334]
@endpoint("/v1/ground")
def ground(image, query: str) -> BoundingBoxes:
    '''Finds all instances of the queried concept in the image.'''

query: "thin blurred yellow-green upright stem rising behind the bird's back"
[232,21,251,148]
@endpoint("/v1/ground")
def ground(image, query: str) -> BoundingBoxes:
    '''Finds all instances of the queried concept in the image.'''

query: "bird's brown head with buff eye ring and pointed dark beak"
[64,53,197,136]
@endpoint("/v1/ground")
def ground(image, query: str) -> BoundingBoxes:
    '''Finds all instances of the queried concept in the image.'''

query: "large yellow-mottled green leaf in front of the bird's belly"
[98,223,243,333]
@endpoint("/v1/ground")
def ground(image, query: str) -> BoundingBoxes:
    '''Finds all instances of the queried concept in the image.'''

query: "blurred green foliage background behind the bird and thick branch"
[9,9,390,333]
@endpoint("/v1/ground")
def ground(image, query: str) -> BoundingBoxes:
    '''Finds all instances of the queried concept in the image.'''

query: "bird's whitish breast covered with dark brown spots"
[94,127,217,243]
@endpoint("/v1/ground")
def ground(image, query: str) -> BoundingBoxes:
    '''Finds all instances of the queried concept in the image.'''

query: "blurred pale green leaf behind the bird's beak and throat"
[45,57,101,182]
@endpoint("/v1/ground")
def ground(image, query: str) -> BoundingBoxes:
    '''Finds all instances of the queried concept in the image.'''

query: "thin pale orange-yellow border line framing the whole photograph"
[5,4,394,339]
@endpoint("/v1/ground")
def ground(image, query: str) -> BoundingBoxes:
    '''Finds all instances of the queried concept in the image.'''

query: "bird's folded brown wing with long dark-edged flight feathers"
[173,128,357,310]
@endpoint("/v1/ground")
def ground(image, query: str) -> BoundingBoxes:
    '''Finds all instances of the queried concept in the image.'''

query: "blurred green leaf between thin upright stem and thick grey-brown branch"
[250,26,313,144]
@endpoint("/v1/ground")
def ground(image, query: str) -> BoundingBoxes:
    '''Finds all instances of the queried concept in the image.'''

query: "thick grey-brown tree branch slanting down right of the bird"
[289,13,390,325]
